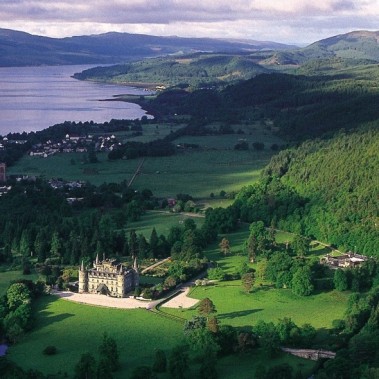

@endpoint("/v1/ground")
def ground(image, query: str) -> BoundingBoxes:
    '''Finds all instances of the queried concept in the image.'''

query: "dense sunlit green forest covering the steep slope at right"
[234,123,379,256]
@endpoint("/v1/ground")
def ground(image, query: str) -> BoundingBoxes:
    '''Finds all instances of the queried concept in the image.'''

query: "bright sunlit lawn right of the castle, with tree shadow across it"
[162,280,350,328]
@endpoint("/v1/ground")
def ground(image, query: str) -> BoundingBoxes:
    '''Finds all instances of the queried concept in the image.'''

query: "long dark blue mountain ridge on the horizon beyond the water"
[0,29,294,66]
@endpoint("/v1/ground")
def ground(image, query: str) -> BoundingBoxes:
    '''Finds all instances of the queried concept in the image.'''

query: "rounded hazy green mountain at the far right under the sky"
[262,31,379,67]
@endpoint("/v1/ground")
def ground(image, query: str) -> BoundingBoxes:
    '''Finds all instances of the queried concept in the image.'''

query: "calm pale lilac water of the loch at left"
[0,66,154,136]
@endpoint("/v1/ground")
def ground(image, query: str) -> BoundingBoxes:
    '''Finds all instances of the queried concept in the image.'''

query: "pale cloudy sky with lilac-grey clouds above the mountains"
[0,0,379,45]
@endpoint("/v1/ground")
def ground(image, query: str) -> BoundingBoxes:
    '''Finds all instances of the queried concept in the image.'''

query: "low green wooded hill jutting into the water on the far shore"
[74,53,269,89]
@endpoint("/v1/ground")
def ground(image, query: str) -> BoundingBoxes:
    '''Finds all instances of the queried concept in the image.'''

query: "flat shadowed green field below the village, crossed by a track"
[8,150,272,198]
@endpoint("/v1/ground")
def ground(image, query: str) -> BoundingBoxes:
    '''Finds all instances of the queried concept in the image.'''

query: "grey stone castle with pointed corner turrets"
[79,255,139,297]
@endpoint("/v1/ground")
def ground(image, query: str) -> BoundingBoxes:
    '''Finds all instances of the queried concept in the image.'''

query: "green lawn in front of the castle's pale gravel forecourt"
[8,296,183,378]
